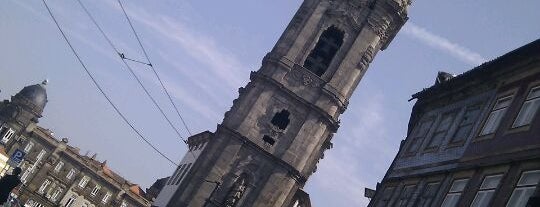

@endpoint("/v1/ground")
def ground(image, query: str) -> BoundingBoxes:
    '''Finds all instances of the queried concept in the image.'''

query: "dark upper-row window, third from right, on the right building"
[450,104,482,143]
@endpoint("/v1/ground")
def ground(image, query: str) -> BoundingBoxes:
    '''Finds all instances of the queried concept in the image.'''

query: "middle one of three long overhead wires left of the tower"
[77,0,187,144]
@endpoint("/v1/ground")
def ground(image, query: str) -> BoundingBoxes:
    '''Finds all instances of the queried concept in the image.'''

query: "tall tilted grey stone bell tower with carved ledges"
[167,0,410,207]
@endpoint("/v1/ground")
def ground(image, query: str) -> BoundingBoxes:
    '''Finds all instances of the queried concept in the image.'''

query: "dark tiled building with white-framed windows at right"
[369,40,540,207]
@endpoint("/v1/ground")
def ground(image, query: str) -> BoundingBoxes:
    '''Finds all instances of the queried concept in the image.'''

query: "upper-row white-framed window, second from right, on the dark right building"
[480,96,513,136]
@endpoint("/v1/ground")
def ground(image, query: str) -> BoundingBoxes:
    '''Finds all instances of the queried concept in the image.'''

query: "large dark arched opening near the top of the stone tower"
[304,26,344,76]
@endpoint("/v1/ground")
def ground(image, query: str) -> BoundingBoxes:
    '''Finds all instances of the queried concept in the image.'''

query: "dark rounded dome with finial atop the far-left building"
[15,80,47,114]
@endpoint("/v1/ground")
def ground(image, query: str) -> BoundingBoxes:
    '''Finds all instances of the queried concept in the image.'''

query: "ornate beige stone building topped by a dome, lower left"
[0,82,150,207]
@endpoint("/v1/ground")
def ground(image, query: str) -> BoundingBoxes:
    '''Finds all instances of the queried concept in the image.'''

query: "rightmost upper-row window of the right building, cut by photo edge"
[512,86,540,128]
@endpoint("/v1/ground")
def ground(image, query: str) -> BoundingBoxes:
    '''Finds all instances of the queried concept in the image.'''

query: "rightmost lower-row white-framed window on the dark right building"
[506,170,540,207]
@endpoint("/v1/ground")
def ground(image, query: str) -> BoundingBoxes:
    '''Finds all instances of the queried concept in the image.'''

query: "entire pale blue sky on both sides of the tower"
[0,0,540,206]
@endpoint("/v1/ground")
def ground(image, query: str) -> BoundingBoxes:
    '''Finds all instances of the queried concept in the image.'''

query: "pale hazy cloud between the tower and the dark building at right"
[312,94,395,206]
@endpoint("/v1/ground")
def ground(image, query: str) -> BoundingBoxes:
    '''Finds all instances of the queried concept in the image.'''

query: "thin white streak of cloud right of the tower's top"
[402,22,486,65]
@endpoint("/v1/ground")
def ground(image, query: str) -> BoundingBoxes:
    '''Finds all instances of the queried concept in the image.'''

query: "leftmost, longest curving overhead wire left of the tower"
[42,0,178,167]
